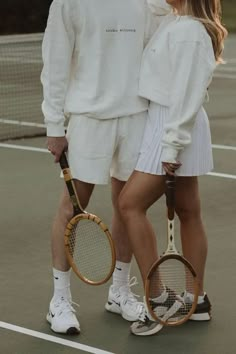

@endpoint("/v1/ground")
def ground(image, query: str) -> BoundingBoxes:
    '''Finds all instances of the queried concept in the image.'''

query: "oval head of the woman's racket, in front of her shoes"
[145,254,199,326]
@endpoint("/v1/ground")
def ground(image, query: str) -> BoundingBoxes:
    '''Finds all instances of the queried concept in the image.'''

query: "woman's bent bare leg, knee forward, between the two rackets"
[119,171,165,283]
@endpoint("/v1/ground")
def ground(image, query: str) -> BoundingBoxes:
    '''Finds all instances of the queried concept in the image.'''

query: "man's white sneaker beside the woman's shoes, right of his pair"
[105,277,143,321]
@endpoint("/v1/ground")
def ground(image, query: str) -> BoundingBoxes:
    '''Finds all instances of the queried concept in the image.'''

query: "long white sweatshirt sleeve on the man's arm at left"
[41,0,75,137]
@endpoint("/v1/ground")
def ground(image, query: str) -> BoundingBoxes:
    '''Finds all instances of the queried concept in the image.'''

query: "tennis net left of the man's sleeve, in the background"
[0,33,45,141]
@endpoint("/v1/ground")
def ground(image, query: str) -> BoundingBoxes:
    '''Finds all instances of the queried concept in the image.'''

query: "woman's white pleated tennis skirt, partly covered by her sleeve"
[135,103,213,176]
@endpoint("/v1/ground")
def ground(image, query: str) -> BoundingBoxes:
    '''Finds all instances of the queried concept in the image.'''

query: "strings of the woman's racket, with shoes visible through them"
[148,259,195,324]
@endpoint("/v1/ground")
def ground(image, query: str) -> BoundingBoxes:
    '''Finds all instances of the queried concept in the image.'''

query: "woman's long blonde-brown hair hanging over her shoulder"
[182,0,228,63]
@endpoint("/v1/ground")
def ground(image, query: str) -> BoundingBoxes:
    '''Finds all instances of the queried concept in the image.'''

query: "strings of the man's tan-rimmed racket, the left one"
[68,219,113,282]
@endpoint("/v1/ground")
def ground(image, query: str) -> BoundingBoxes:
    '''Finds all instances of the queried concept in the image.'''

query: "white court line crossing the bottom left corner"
[0,321,114,354]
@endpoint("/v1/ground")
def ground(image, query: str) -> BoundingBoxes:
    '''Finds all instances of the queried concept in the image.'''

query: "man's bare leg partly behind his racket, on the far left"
[51,180,94,272]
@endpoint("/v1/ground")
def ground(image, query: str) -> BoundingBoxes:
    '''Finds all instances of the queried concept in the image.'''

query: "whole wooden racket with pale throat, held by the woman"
[145,175,199,326]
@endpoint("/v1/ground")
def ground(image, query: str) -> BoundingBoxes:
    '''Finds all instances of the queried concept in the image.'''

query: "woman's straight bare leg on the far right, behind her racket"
[176,177,207,295]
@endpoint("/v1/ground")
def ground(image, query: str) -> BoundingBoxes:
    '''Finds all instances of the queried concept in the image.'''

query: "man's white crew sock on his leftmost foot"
[53,268,71,301]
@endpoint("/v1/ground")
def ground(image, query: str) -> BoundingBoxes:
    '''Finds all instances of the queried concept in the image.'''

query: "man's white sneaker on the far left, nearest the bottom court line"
[47,297,80,334]
